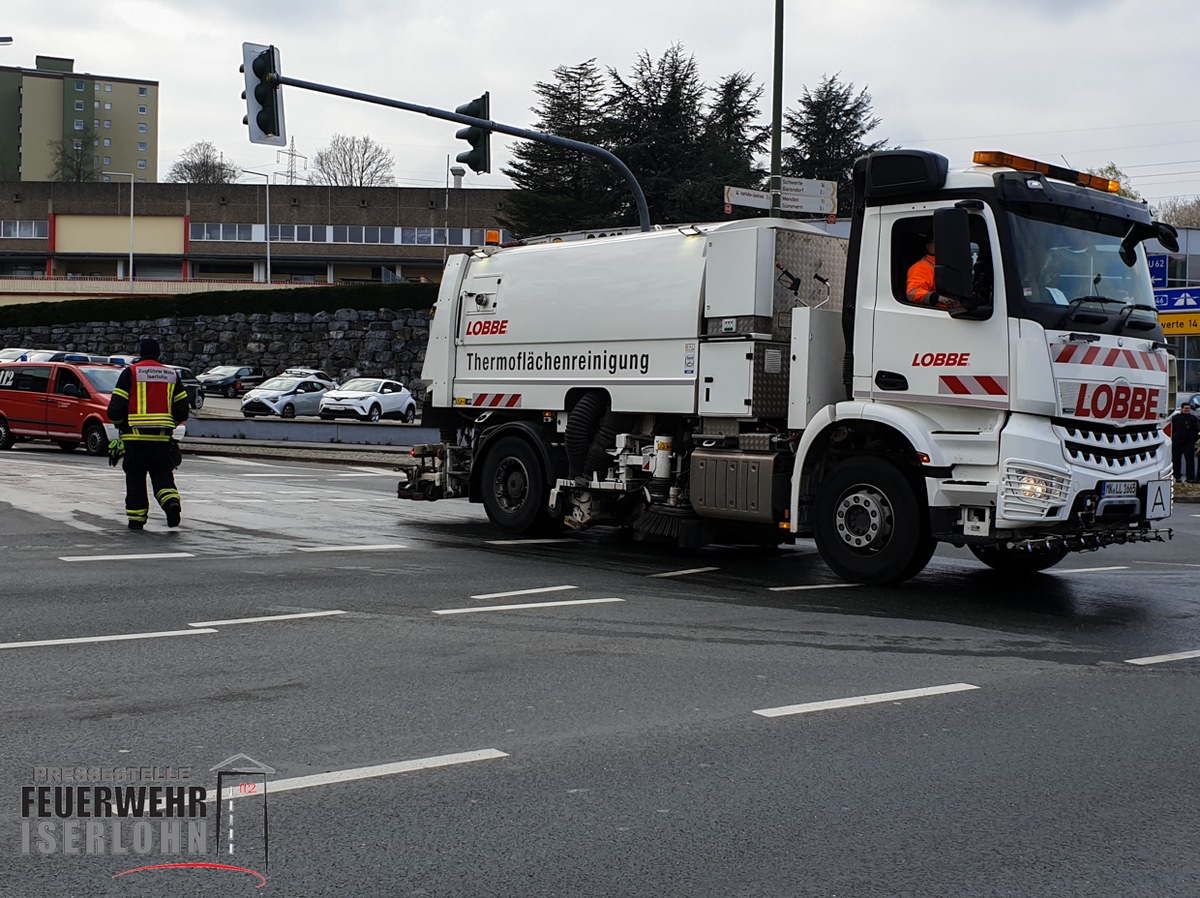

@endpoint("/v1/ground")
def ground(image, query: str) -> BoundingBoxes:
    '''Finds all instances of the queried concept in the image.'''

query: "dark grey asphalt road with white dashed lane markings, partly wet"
[0,447,1200,896]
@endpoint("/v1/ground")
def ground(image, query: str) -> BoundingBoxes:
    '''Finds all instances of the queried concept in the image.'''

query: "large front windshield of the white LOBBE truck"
[1009,204,1163,340]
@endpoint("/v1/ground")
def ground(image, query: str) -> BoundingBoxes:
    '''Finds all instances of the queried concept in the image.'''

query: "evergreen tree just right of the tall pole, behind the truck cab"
[782,74,886,215]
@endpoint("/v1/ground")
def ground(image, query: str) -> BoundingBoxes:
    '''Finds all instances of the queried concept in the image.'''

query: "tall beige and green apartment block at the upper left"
[0,56,158,182]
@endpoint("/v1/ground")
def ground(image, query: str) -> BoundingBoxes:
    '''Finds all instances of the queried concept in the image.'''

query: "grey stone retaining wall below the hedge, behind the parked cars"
[0,309,430,402]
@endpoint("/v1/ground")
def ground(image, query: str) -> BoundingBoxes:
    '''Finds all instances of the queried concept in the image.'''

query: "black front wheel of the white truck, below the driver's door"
[812,457,935,583]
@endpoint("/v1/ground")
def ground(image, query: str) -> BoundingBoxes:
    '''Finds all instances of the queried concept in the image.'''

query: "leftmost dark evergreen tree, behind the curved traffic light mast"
[499,59,624,237]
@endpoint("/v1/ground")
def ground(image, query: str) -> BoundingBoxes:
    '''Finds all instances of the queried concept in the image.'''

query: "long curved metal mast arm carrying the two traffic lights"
[238,48,650,231]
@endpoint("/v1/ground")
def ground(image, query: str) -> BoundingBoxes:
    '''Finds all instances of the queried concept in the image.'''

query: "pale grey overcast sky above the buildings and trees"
[9,0,1200,206]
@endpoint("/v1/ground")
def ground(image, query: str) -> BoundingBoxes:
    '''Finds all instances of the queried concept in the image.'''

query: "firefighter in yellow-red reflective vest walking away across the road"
[108,337,188,531]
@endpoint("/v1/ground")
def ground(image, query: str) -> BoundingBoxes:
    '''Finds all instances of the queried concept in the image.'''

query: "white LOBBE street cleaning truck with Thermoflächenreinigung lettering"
[398,150,1175,583]
